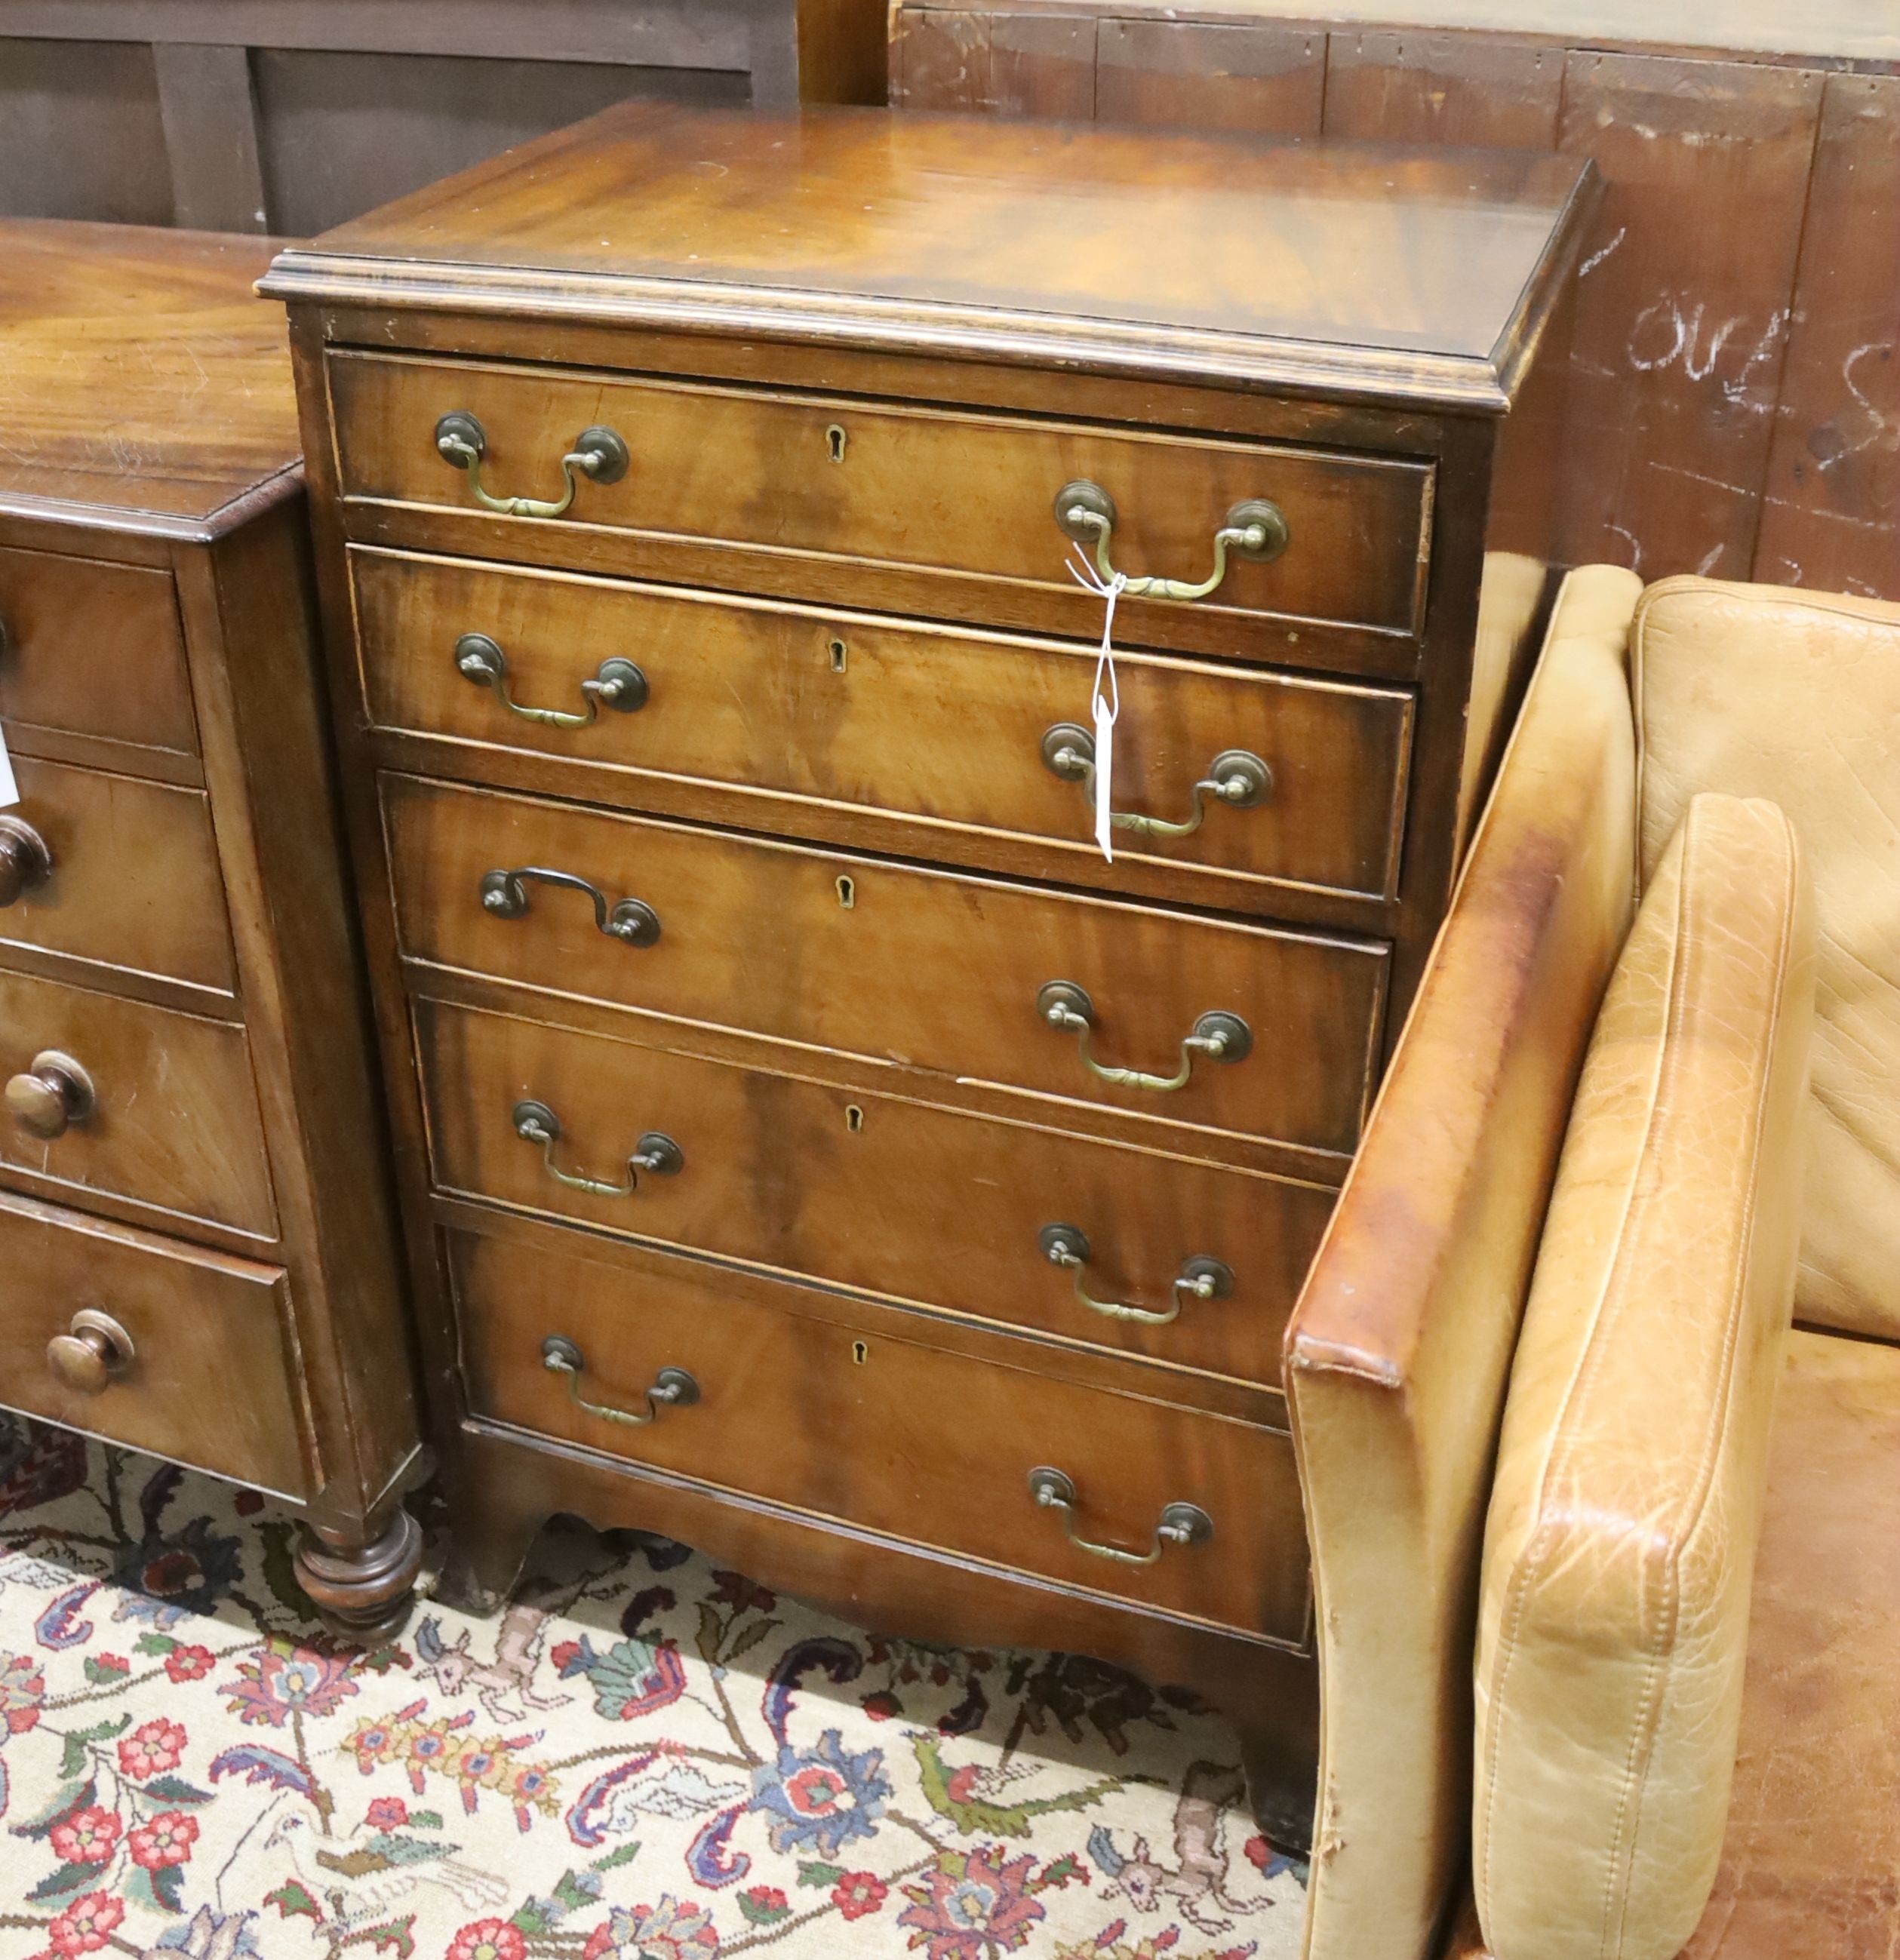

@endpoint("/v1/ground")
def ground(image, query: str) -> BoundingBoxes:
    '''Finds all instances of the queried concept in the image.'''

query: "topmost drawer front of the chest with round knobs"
[0,548,198,772]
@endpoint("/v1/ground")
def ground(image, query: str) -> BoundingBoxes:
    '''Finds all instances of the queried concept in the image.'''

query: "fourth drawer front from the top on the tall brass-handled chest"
[416,1002,1333,1386]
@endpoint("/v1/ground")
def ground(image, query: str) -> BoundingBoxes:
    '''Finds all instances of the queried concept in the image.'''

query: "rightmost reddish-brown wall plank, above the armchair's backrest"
[1755,75,1900,598]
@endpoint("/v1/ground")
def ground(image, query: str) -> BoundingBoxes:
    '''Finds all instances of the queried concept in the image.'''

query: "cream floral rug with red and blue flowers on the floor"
[0,1415,1306,1960]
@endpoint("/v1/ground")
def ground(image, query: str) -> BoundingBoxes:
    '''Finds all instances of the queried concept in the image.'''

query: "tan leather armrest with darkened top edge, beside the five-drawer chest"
[1287,567,1641,1960]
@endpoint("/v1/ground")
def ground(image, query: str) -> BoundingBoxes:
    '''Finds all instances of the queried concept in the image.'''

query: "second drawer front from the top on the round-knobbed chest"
[0,757,237,996]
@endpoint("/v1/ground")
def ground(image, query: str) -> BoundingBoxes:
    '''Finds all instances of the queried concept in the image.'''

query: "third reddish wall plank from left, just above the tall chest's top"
[1326,33,1563,149]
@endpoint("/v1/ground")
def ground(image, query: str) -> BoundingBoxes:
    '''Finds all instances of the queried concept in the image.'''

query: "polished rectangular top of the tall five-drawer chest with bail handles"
[265,102,1596,407]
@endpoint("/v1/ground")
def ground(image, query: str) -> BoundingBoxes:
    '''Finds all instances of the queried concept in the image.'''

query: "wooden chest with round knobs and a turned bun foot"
[0,223,420,1639]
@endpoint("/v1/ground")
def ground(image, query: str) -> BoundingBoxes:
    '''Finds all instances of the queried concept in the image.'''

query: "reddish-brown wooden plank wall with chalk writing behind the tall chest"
[890,0,1900,600]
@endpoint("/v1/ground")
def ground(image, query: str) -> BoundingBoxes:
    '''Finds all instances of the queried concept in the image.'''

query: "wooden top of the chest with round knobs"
[0,220,298,531]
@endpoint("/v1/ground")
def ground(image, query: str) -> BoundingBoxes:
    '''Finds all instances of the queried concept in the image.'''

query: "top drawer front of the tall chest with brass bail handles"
[330,353,1431,633]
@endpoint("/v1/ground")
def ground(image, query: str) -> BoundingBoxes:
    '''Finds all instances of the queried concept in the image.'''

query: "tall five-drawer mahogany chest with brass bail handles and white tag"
[265,106,1594,1836]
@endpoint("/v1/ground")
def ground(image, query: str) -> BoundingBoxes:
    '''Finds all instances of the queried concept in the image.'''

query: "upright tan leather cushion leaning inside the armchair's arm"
[1473,796,1814,1960]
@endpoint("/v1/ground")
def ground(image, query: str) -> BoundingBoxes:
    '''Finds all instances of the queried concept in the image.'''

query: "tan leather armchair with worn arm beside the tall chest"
[1287,567,1900,1960]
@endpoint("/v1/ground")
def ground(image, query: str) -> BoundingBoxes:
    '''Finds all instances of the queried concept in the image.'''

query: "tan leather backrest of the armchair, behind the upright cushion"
[1631,578,1900,1341]
